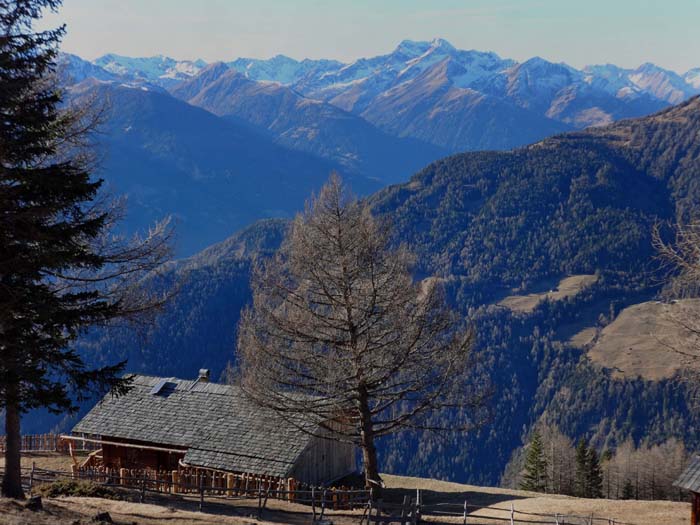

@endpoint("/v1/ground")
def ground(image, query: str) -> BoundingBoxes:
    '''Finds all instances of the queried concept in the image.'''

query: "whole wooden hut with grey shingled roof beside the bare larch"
[65,370,356,485]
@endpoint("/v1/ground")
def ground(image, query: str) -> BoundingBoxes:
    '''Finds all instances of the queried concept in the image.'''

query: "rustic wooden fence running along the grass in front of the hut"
[0,467,640,525]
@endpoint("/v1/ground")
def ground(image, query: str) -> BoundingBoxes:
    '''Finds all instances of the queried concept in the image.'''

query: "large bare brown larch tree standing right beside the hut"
[238,175,482,495]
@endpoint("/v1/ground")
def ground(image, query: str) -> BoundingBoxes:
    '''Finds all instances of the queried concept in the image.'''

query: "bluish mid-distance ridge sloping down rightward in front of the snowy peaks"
[170,63,448,183]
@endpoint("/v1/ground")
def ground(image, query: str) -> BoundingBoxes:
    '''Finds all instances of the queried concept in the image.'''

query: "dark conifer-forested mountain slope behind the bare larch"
[30,98,700,484]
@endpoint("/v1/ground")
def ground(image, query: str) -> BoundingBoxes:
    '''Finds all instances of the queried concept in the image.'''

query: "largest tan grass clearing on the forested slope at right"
[588,299,700,380]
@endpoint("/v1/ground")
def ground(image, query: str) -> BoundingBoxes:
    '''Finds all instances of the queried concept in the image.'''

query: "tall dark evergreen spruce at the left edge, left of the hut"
[0,0,169,498]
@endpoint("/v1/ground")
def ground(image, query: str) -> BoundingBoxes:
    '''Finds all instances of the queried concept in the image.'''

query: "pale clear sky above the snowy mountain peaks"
[39,0,700,73]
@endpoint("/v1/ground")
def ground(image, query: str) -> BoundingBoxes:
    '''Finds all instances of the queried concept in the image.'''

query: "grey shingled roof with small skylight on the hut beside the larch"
[73,375,312,477]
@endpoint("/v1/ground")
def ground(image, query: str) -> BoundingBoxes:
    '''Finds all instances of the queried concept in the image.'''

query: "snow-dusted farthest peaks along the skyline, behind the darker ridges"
[67,39,700,145]
